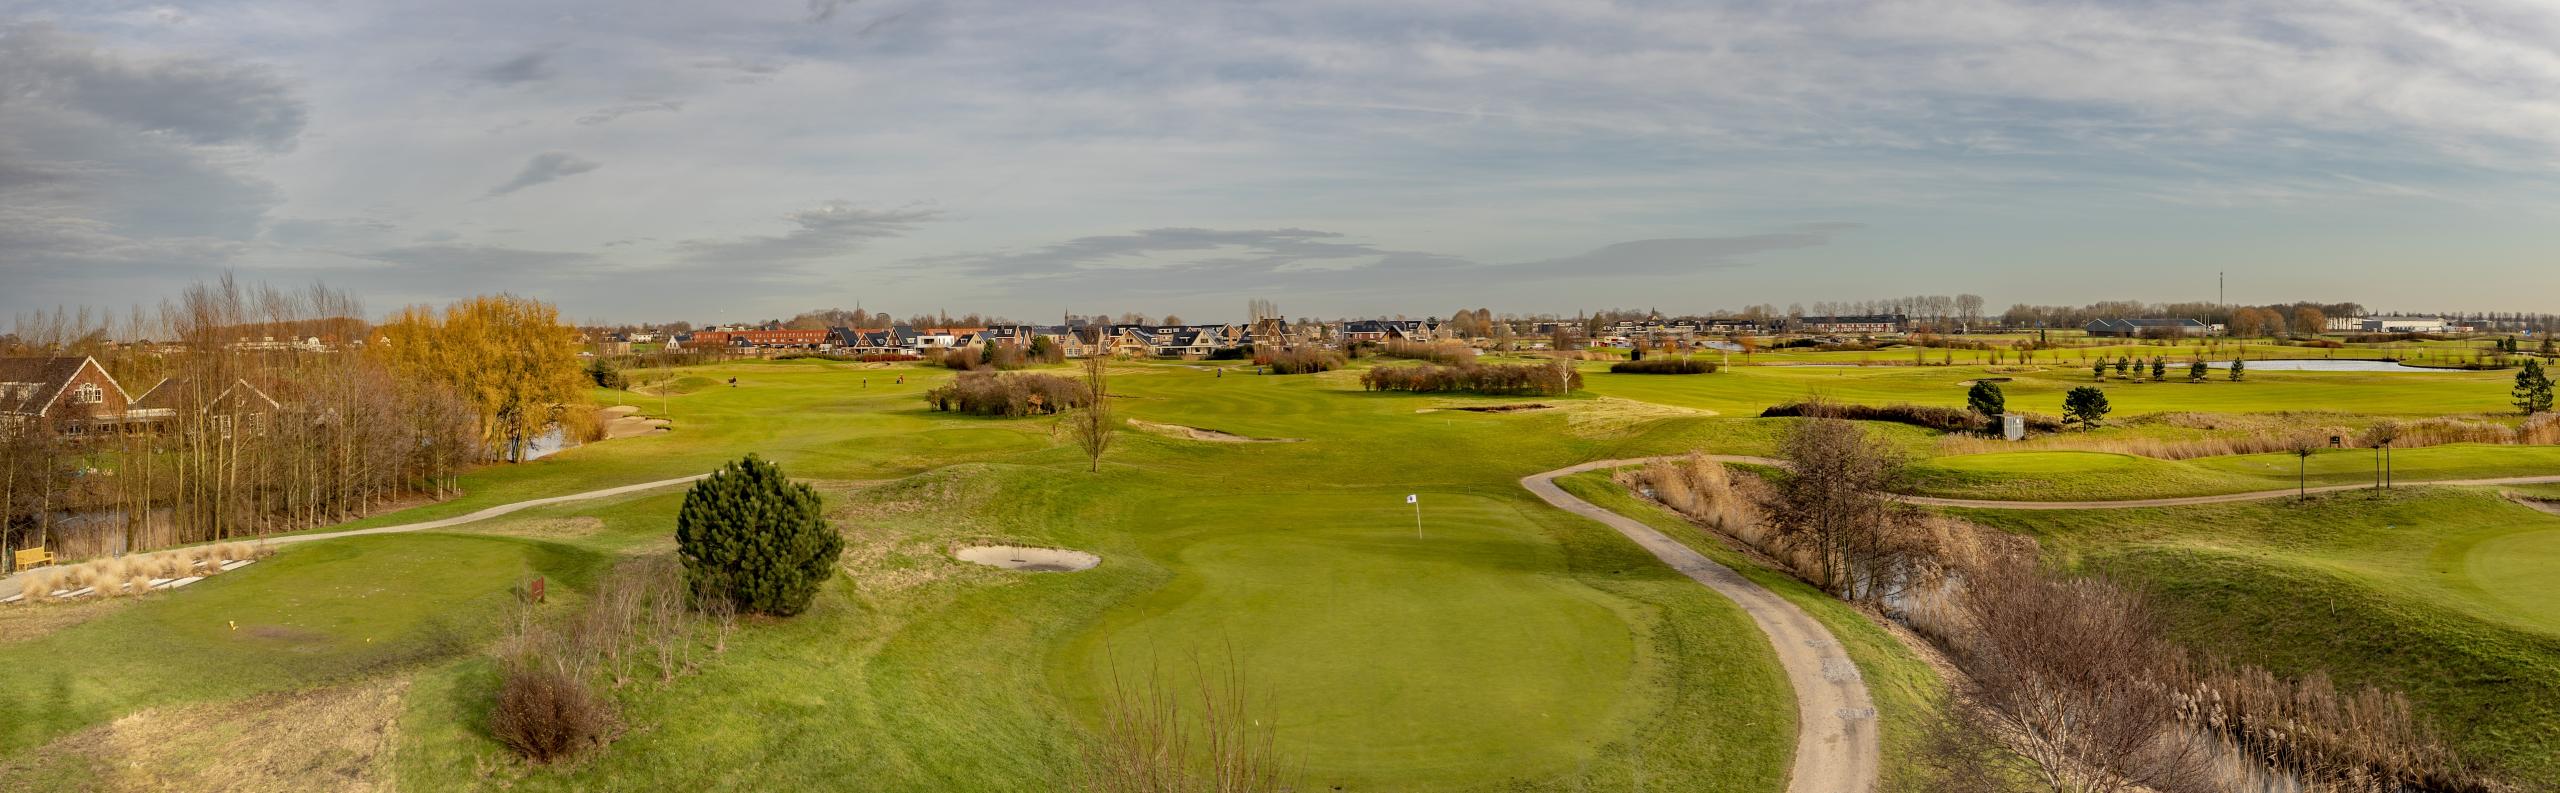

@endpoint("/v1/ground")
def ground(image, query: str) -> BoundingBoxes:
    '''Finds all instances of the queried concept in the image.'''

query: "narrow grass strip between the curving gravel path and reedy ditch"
[1556,471,1946,790]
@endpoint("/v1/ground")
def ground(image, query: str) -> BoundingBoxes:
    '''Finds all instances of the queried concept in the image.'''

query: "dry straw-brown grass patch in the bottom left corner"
[0,678,410,790]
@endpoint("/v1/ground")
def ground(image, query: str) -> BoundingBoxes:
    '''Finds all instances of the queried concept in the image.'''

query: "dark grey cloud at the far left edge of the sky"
[0,26,305,299]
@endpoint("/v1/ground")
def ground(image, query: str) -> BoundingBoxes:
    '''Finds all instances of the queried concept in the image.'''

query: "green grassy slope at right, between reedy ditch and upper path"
[1961,489,2560,788]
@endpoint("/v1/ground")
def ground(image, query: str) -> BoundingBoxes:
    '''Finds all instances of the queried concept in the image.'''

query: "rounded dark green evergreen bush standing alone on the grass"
[676,455,845,616]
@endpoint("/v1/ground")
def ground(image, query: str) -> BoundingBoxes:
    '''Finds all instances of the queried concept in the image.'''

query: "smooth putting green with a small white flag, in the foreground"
[1065,494,1646,788]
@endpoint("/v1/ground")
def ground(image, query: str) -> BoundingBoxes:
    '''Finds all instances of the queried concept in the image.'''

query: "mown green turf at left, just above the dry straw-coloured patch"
[0,535,596,752]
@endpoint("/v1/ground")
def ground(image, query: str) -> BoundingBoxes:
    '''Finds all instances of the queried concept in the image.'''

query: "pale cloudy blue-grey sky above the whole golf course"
[0,0,2560,322]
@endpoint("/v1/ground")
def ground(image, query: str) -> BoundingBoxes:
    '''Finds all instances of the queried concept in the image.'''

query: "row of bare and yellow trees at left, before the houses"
[0,276,596,558]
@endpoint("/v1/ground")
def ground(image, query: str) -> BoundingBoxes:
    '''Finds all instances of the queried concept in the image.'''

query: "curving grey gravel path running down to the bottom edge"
[1521,460,1884,793]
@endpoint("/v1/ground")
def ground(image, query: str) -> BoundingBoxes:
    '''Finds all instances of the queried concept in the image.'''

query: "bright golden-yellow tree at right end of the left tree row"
[374,294,586,463]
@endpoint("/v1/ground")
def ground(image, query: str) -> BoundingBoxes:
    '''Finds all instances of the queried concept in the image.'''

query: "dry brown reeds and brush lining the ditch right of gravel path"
[1615,455,2496,793]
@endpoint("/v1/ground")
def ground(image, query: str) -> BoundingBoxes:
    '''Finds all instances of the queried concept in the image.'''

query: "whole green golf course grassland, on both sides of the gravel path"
[0,348,2560,790]
